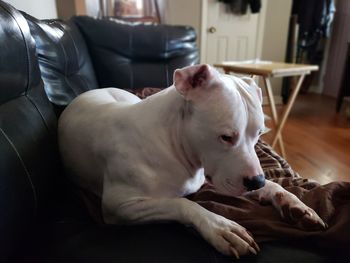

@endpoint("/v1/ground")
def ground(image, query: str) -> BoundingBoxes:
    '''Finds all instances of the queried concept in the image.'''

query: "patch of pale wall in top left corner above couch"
[4,0,57,19]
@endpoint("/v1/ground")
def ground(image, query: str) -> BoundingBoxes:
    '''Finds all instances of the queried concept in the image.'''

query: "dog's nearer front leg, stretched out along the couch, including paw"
[104,198,260,258]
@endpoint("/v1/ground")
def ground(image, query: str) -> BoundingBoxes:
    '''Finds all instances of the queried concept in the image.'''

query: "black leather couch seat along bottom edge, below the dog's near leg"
[44,223,330,263]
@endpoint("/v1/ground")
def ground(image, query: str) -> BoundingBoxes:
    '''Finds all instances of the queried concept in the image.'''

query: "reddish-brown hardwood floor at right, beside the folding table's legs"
[263,94,350,184]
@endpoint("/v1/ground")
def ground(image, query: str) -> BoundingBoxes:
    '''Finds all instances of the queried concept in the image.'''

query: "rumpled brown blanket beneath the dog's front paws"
[188,141,350,253]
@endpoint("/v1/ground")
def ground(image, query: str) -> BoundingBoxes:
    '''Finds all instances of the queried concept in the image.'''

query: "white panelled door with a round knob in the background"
[202,0,260,64]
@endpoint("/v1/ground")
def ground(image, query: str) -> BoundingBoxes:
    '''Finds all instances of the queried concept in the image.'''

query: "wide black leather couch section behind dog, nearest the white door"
[72,16,198,90]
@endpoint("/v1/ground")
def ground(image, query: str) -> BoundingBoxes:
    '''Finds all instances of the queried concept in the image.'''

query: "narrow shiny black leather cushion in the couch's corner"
[24,14,98,110]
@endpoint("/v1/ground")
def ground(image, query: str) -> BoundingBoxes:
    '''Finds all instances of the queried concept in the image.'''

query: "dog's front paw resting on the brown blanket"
[273,192,327,230]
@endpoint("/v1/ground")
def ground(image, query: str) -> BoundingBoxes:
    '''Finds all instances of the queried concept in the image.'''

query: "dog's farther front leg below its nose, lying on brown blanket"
[246,180,326,229]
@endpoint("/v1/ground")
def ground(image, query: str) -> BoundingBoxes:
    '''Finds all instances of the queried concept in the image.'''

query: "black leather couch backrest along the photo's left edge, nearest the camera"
[0,1,61,262]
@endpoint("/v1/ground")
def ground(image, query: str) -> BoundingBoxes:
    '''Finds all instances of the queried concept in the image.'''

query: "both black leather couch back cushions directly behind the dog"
[23,13,198,115]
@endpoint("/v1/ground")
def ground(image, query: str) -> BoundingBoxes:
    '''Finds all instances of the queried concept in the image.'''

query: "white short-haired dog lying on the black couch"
[59,65,325,257]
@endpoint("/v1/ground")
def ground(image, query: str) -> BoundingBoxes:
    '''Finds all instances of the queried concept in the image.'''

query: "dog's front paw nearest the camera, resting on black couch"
[198,212,260,259]
